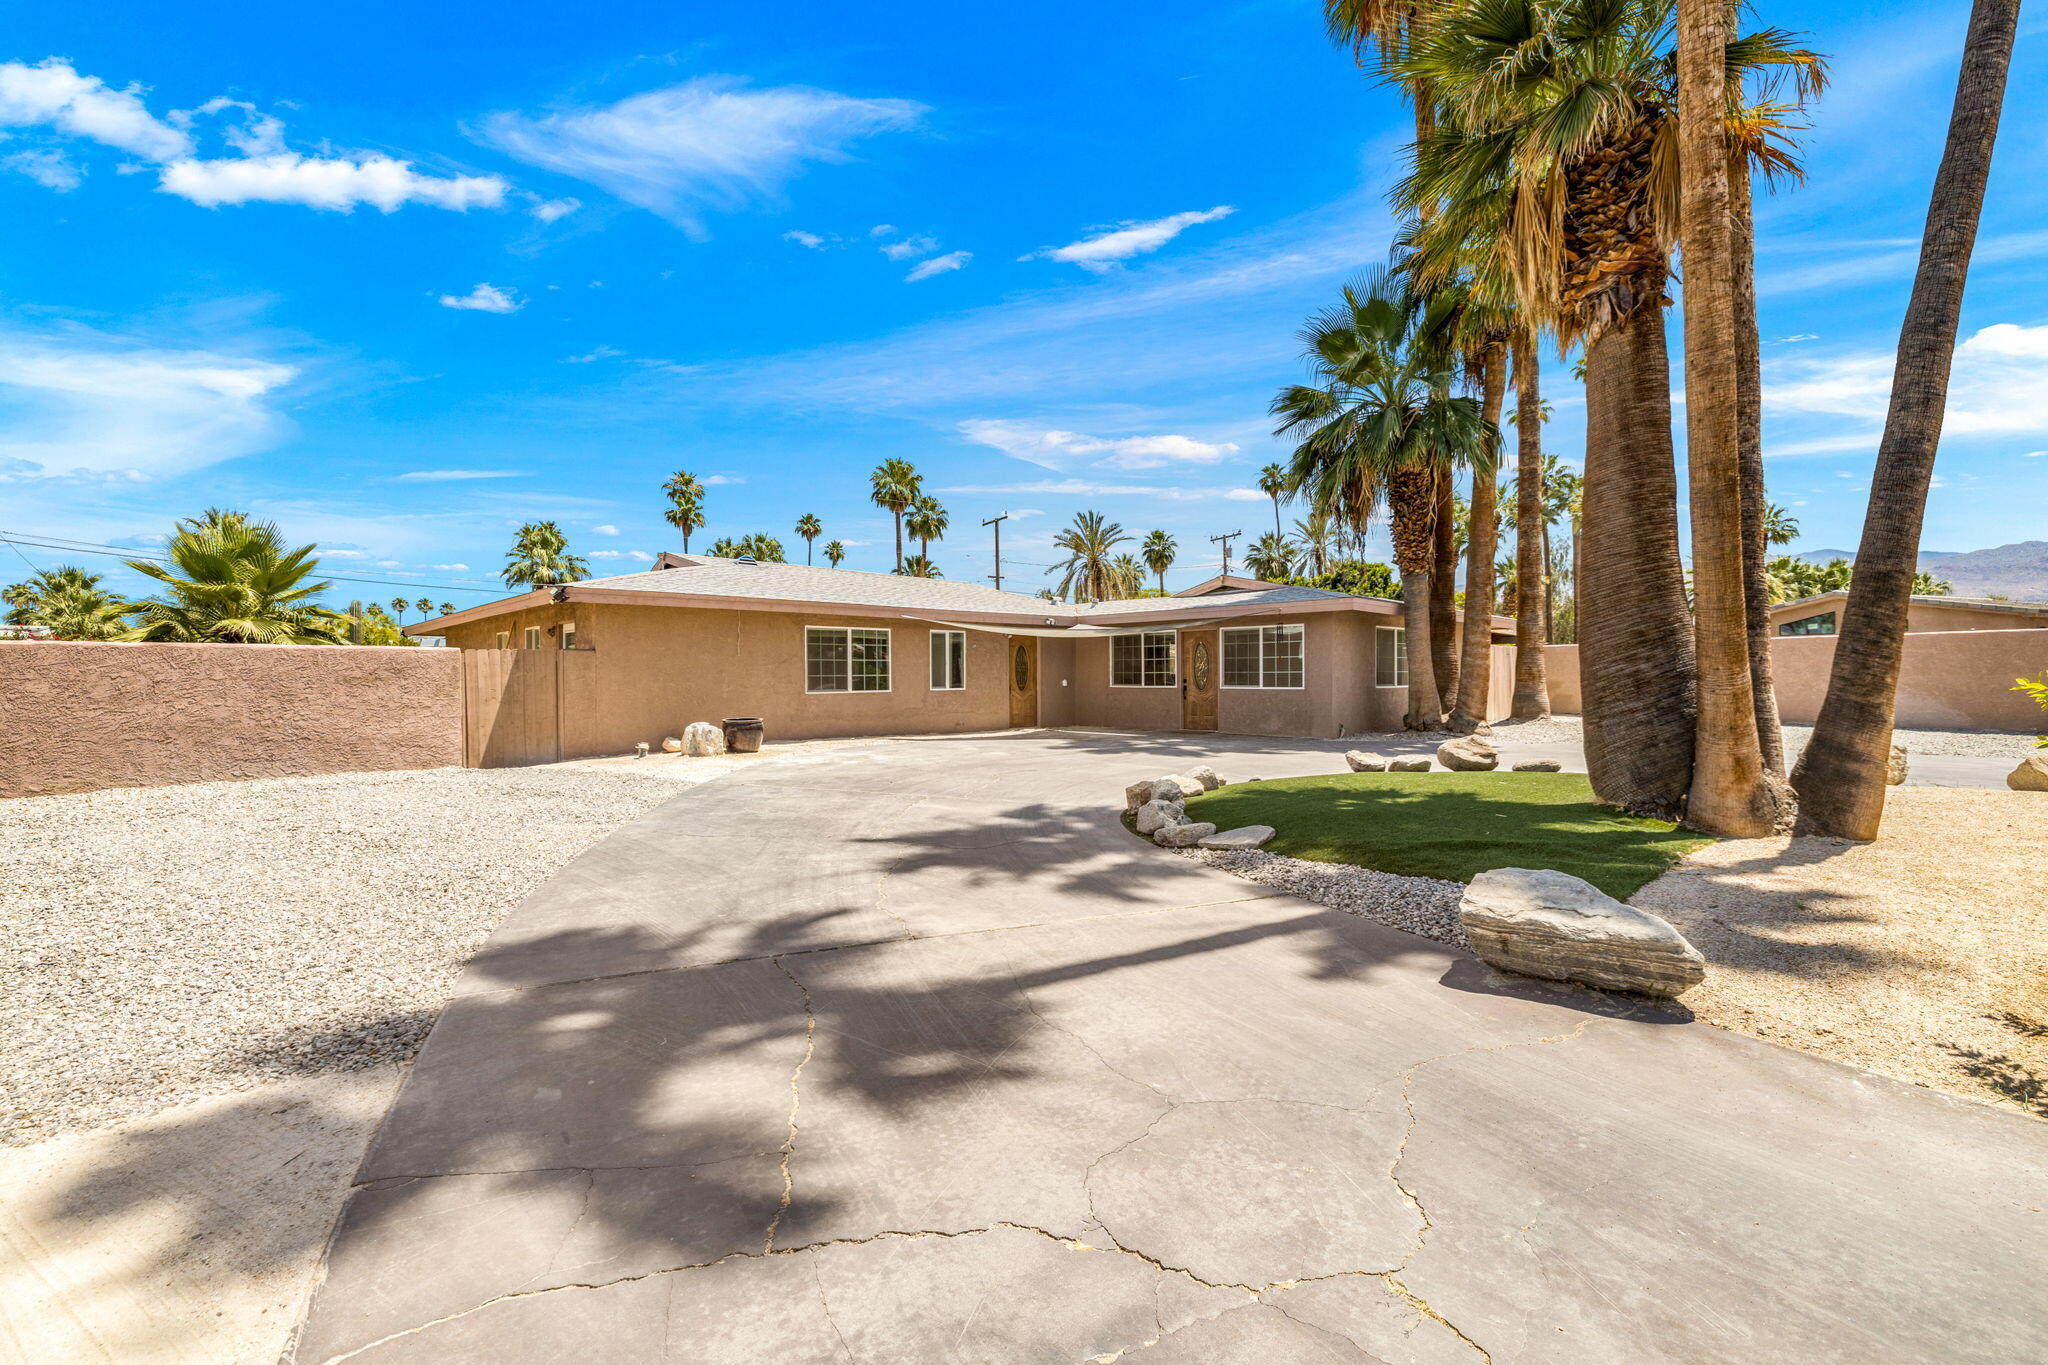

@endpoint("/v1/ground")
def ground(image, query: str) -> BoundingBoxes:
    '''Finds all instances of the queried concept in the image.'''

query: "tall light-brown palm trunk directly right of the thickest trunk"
[1677,0,1792,837]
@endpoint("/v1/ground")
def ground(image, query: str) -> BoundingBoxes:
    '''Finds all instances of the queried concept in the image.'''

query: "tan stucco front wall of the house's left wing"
[446,602,1024,759]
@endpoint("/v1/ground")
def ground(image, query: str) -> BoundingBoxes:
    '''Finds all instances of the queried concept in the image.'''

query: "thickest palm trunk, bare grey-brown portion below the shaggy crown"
[1579,304,1694,819]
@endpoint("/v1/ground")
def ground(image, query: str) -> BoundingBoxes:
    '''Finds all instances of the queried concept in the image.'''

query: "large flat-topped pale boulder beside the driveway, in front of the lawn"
[1458,868,1706,997]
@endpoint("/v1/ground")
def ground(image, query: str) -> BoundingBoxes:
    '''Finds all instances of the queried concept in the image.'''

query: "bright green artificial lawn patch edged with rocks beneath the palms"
[1188,772,1712,900]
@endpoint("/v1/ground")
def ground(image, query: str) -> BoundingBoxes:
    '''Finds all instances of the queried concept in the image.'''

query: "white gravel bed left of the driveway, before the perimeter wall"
[0,765,678,1144]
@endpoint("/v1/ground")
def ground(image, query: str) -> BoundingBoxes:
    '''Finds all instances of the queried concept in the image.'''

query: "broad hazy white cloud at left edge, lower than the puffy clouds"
[0,327,297,479]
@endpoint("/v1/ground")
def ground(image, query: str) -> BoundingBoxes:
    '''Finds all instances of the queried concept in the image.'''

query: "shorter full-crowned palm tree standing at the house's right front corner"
[1272,270,1499,731]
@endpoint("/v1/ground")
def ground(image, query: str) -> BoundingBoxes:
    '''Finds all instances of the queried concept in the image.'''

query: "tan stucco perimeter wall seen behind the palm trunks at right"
[1544,630,2048,731]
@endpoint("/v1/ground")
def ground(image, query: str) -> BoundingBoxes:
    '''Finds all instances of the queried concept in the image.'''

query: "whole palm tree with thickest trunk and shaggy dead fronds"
[1401,0,1812,814]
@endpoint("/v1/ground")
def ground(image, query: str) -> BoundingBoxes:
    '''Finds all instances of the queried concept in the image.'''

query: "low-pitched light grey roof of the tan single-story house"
[406,555,1513,634]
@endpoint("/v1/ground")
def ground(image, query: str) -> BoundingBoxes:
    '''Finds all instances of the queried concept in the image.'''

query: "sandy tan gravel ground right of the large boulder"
[1632,786,2048,1117]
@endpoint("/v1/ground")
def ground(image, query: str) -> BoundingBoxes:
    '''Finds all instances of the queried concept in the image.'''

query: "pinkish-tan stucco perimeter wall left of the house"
[0,643,463,796]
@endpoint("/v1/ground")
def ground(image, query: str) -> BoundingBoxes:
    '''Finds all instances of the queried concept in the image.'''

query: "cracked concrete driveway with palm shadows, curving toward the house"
[295,733,2048,1365]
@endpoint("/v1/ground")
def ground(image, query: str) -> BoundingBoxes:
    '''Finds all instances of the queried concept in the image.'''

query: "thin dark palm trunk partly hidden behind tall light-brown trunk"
[1729,151,1786,778]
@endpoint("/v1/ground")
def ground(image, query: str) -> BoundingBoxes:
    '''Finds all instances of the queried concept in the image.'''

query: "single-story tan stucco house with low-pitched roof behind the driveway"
[406,555,1513,761]
